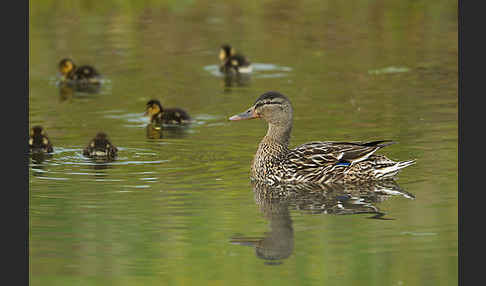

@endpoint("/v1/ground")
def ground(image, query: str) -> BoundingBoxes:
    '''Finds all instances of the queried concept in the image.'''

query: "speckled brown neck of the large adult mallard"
[251,123,292,178]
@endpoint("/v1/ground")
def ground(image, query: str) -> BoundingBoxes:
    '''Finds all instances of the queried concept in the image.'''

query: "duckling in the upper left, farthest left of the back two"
[59,59,101,84]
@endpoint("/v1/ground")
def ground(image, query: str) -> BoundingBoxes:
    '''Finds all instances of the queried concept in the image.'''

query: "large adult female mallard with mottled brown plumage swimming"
[229,91,415,183]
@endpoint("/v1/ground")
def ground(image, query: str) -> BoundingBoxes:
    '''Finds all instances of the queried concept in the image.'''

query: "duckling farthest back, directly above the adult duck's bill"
[219,44,252,74]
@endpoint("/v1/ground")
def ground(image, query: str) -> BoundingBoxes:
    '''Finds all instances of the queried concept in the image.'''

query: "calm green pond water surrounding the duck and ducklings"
[26,0,458,285]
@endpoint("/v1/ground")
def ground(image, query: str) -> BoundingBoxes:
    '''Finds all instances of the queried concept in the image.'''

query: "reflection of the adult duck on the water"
[231,180,415,265]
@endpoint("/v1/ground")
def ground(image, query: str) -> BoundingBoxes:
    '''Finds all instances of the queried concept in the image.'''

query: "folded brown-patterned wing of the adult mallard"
[288,140,395,167]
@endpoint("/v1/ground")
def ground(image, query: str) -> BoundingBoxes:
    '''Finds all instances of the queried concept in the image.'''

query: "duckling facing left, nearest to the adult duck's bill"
[145,99,191,128]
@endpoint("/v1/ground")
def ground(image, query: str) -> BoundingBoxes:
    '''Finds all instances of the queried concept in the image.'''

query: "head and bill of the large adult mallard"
[229,91,293,126]
